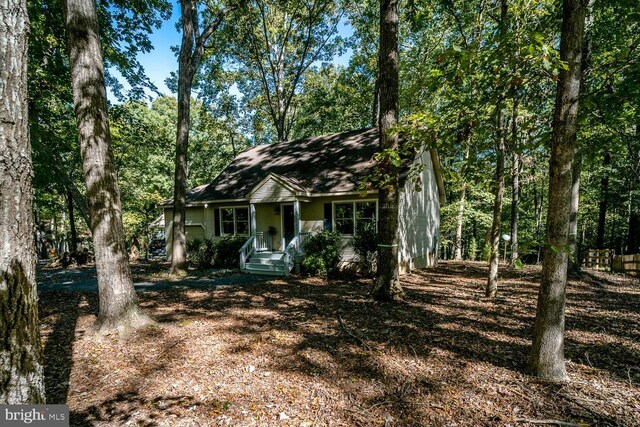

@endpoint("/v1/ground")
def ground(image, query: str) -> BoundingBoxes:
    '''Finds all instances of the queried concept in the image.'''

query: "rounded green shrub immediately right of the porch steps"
[302,230,342,277]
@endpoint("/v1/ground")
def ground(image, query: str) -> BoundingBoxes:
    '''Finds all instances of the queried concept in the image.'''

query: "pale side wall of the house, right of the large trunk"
[398,152,440,272]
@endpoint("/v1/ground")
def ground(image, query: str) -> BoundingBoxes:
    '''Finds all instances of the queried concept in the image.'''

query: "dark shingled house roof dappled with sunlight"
[163,128,444,206]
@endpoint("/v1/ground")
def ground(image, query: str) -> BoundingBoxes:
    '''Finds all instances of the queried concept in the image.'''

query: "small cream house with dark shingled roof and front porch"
[163,128,445,275]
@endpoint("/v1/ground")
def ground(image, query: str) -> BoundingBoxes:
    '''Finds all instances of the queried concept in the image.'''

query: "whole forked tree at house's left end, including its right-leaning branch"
[171,0,240,273]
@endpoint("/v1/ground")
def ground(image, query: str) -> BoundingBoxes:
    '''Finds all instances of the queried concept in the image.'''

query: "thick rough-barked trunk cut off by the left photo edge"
[0,0,45,404]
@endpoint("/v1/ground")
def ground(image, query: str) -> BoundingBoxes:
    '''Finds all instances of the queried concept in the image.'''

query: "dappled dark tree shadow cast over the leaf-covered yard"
[37,263,640,426]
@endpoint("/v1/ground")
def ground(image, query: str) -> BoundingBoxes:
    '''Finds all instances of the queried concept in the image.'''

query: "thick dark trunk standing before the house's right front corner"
[371,0,402,301]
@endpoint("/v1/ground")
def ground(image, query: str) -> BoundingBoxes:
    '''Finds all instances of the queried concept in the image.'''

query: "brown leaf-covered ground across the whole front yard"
[40,262,640,426]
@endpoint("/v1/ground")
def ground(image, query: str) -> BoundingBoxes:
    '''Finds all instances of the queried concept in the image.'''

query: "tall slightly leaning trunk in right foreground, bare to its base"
[529,0,588,380]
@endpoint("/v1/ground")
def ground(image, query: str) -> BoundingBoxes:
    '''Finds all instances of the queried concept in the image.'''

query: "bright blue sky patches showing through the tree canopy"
[115,2,353,100]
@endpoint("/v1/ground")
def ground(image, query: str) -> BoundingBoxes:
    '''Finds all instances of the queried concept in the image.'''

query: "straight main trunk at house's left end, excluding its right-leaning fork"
[171,0,198,273]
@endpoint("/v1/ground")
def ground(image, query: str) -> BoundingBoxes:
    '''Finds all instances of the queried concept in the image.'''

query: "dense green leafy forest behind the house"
[29,0,640,263]
